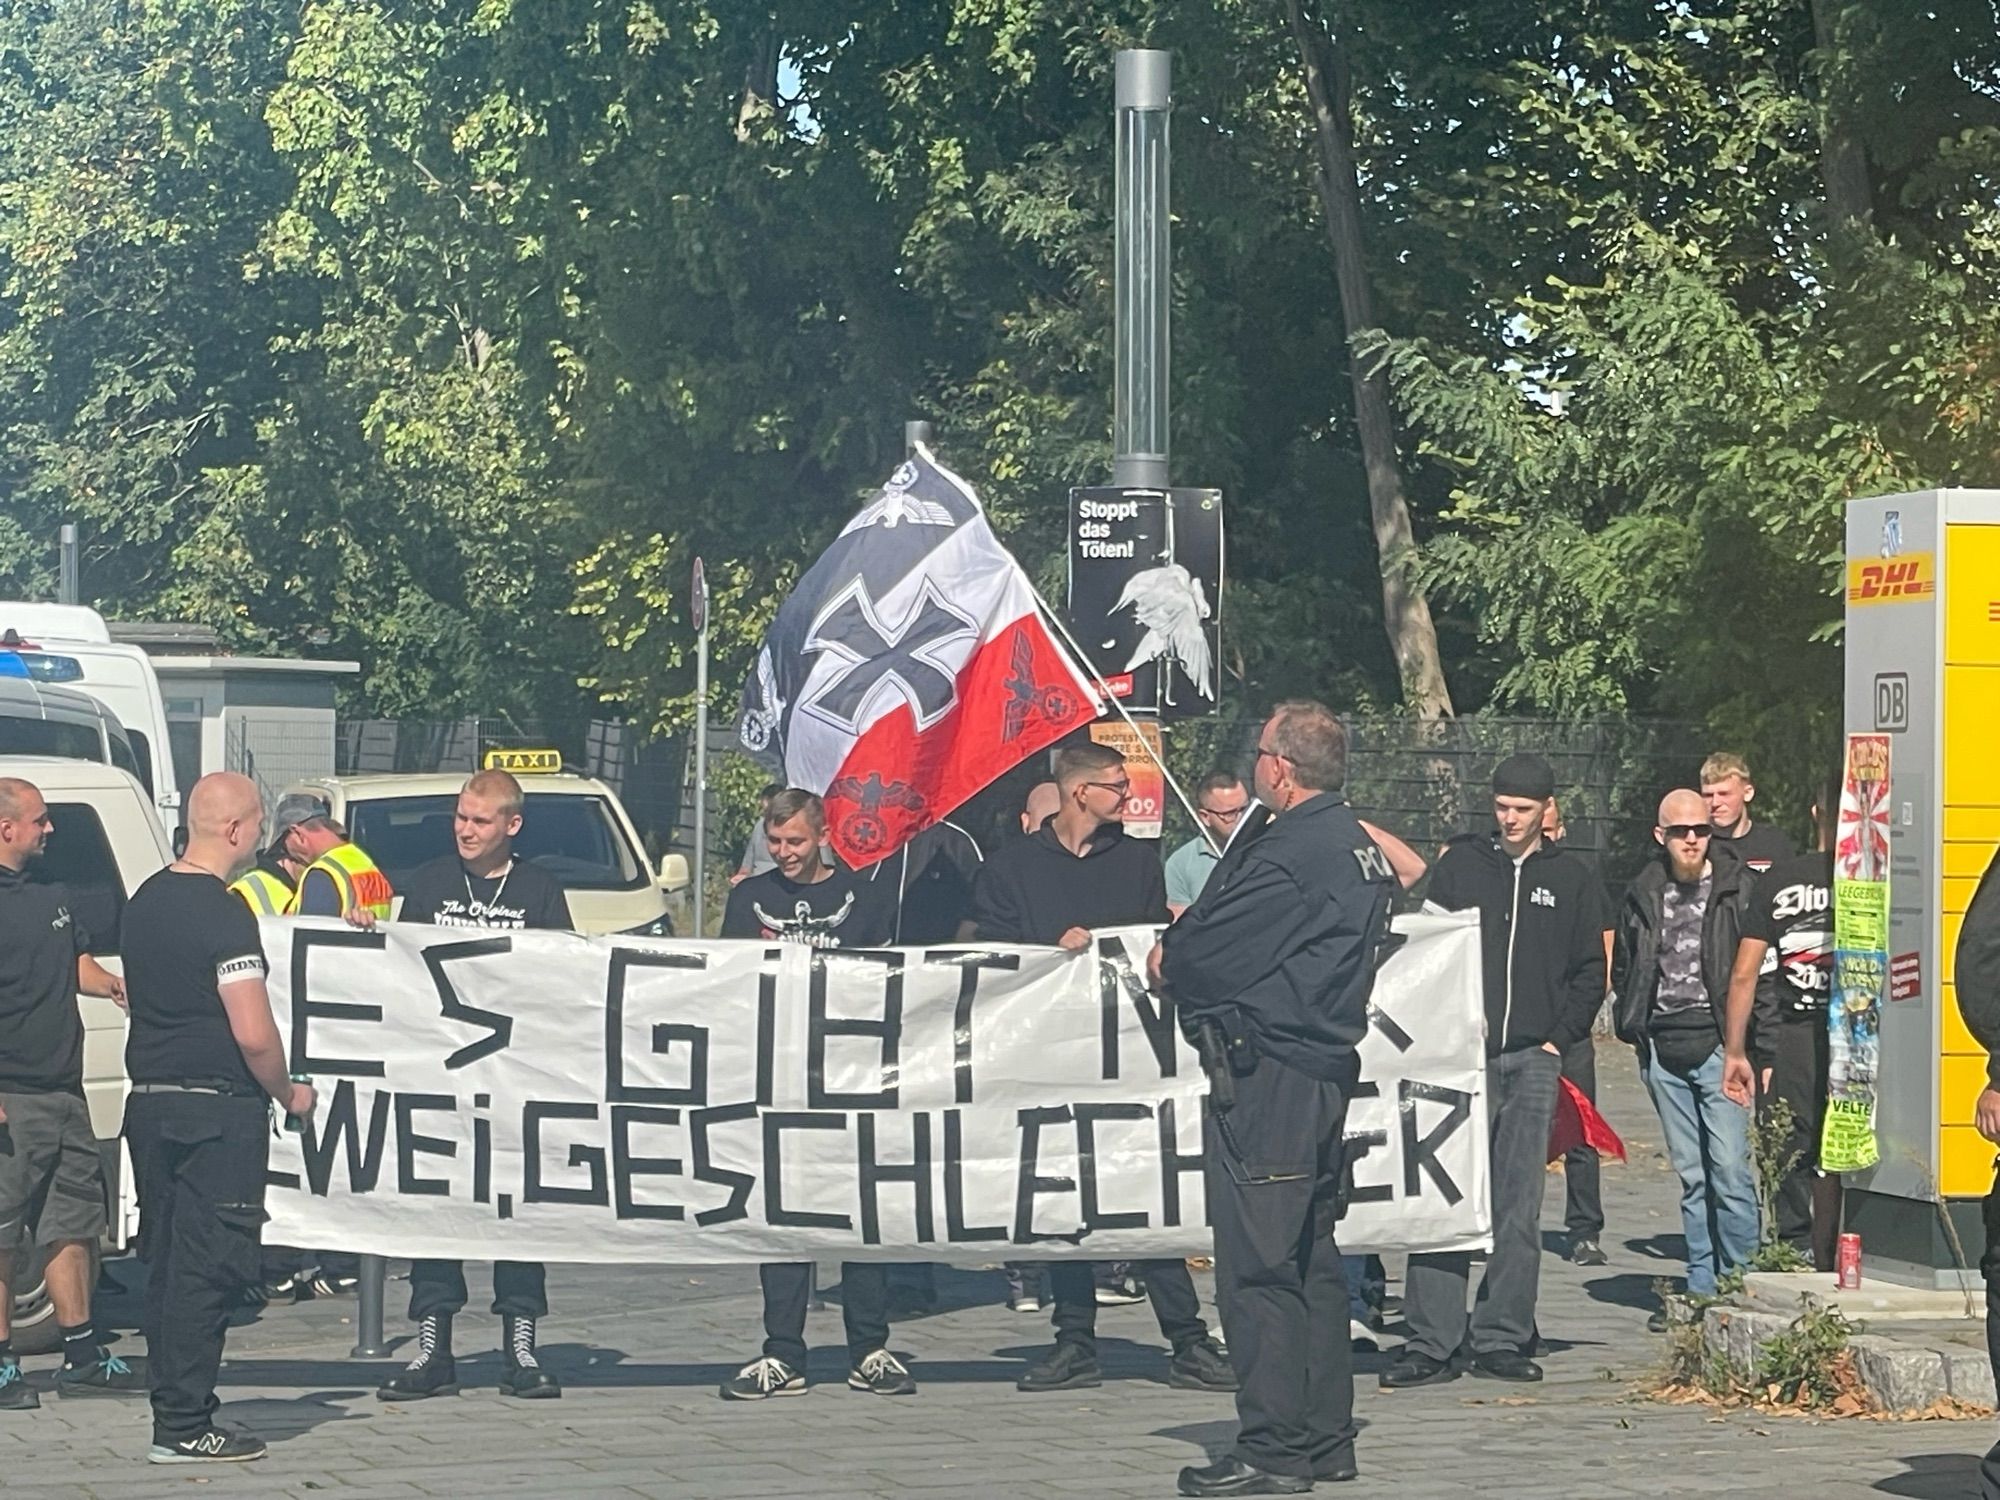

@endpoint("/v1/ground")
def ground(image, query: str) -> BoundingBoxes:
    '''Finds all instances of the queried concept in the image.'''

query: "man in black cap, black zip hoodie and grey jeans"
[1380,756,1604,1390]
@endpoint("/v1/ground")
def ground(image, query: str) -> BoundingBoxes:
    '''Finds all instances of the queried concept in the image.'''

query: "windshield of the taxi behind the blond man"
[348,792,646,890]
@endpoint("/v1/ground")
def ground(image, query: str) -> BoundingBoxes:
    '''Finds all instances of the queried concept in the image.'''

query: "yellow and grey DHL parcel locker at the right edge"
[1846,490,2000,1286]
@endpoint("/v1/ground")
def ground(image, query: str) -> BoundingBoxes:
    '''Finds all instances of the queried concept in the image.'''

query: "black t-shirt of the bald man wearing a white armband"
[118,868,264,1094]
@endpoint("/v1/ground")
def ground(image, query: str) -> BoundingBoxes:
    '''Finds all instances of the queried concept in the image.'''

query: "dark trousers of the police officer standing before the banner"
[1206,1058,1354,1478]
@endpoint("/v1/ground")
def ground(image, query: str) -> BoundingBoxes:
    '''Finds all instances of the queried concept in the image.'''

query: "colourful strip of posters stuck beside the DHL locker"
[1820,734,1890,1172]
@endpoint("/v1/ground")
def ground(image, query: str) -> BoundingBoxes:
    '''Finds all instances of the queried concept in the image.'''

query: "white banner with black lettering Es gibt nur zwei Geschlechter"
[262,916,1488,1264]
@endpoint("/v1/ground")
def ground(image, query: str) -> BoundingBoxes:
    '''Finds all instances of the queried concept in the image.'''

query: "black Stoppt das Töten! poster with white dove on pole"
[1070,486,1222,718]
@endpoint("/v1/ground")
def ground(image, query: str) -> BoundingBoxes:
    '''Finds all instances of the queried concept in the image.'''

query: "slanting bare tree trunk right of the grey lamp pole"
[1284,0,1452,720]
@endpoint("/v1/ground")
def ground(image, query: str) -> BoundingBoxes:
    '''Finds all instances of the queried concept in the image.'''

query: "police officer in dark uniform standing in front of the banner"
[1152,700,1396,1494]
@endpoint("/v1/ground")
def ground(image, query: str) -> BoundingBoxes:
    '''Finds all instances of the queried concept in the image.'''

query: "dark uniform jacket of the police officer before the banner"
[1160,792,1396,1084]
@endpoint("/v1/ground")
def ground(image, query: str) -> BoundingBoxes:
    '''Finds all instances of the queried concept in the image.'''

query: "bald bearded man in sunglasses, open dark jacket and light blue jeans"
[1612,788,1758,1330]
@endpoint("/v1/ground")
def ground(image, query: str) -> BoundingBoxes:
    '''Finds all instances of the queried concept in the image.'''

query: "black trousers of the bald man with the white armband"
[126,1094,270,1442]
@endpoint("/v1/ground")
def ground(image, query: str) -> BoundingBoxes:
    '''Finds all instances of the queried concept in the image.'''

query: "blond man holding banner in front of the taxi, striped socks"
[376,770,576,1402]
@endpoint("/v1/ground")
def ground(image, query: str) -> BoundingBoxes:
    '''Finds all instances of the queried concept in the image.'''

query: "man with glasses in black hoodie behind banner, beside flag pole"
[972,742,1236,1390]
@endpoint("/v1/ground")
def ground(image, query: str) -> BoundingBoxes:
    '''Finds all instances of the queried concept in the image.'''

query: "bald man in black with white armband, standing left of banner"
[122,772,312,1464]
